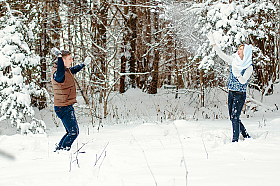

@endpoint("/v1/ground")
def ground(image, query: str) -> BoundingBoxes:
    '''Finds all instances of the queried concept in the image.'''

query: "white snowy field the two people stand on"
[0,87,280,186]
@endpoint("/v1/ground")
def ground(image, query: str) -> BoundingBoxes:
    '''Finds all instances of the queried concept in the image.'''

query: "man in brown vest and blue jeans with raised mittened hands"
[51,48,91,151]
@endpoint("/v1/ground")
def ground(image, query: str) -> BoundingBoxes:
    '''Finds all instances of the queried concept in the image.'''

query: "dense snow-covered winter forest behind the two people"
[0,0,280,131]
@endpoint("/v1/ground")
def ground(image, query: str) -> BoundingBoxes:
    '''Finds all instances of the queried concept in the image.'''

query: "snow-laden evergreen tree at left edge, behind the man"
[0,3,45,132]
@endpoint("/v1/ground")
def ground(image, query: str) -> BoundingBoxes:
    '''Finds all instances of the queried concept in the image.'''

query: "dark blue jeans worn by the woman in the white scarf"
[228,90,248,142]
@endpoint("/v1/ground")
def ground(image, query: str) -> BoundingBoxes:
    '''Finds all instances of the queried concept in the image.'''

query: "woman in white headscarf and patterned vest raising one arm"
[207,32,253,142]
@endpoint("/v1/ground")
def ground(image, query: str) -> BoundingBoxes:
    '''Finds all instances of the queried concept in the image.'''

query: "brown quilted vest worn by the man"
[51,64,77,107]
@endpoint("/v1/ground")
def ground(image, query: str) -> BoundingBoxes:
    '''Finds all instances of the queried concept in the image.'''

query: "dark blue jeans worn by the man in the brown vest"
[54,105,79,148]
